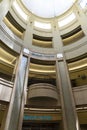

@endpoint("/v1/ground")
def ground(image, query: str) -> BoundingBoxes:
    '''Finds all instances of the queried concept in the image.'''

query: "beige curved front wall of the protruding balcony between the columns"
[28,83,58,100]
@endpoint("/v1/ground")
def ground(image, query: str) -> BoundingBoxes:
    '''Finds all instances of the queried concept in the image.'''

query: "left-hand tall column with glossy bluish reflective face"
[3,49,29,130]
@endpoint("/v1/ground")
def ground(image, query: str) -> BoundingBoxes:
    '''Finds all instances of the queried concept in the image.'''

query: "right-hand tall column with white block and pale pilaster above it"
[54,30,80,130]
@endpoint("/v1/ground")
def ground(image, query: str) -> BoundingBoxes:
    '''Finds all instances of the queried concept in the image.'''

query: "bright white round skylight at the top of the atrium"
[21,0,76,18]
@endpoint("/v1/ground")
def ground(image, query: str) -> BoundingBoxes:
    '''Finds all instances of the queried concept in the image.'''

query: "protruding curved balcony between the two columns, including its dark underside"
[28,83,58,106]
